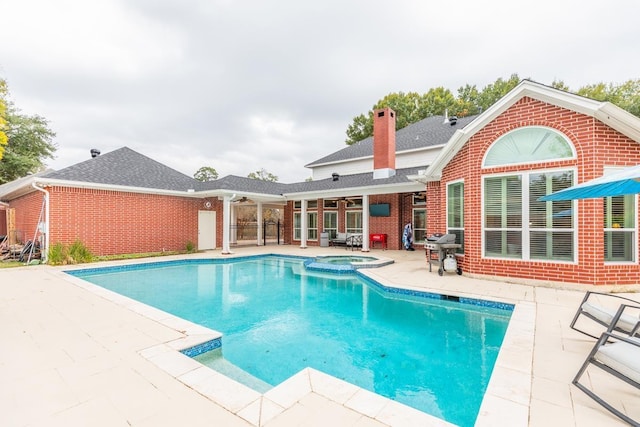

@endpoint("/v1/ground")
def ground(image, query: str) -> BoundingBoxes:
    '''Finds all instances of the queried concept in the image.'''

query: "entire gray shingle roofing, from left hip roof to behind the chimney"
[33,116,464,195]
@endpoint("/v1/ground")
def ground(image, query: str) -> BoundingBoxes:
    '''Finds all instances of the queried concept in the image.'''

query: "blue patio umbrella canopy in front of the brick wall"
[538,165,640,202]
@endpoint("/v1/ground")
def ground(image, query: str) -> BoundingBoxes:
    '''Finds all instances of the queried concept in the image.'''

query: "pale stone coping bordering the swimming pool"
[57,254,536,427]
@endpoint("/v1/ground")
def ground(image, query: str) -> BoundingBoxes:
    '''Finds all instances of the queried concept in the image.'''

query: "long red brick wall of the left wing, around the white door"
[48,187,222,255]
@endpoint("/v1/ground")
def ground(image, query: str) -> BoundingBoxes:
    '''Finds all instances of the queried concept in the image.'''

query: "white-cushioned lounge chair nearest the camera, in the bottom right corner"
[572,330,640,426]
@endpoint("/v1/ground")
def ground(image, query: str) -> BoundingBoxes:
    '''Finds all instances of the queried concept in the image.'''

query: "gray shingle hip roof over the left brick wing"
[47,147,200,191]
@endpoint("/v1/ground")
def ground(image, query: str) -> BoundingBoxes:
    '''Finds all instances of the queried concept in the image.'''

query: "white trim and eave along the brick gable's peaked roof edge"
[421,80,640,181]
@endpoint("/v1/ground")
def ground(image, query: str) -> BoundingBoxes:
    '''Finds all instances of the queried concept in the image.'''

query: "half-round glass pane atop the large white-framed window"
[484,126,575,167]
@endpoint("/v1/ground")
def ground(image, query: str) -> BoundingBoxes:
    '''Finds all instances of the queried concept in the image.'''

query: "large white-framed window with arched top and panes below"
[482,126,577,262]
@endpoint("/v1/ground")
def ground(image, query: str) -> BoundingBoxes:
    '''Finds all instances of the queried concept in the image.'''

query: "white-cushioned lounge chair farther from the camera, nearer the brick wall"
[569,291,640,339]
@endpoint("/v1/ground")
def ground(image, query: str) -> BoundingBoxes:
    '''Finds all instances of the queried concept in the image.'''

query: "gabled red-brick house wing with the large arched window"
[417,81,640,285]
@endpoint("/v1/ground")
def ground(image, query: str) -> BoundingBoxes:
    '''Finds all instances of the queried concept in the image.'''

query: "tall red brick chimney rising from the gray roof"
[373,107,396,179]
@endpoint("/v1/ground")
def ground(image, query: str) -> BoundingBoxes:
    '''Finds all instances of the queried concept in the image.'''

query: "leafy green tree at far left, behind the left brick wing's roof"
[0,84,56,184]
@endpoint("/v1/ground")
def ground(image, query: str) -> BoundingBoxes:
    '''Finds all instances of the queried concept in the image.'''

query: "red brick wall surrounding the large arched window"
[438,98,640,285]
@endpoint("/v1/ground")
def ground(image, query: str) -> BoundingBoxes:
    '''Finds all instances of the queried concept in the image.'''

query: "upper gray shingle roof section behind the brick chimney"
[306,116,477,167]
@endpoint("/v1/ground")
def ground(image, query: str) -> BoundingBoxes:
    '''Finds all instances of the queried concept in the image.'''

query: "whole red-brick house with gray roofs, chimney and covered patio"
[0,80,640,284]
